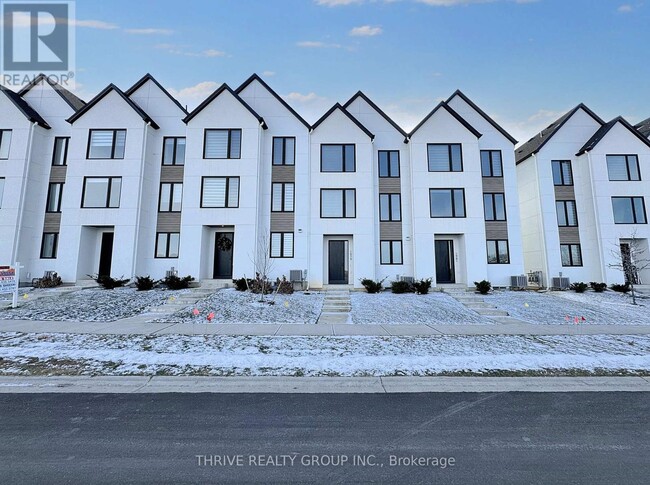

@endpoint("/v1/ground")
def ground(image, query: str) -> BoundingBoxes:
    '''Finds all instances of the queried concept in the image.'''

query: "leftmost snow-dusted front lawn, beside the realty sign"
[0,288,175,322]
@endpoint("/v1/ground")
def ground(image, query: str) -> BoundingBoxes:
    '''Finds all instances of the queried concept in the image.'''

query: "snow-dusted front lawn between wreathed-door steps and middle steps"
[156,288,323,324]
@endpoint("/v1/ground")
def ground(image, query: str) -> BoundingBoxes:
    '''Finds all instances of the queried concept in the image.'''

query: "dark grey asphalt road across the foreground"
[0,393,650,485]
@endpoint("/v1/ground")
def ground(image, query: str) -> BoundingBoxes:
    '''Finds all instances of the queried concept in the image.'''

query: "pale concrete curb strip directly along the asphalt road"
[0,376,650,394]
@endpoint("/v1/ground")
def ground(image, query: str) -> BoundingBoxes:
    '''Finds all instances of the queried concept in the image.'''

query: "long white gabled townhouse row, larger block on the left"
[0,74,524,288]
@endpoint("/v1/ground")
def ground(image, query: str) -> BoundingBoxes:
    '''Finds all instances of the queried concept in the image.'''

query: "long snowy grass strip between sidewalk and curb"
[0,333,650,376]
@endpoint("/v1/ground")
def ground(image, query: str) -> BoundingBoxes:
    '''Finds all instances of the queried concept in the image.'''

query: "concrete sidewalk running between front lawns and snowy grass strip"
[0,315,650,336]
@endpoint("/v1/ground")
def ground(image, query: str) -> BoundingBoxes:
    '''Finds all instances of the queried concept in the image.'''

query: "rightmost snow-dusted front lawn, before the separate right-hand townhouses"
[485,291,650,325]
